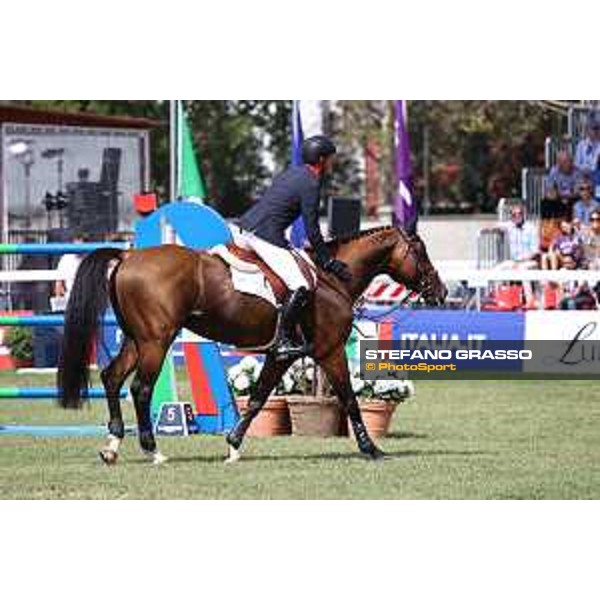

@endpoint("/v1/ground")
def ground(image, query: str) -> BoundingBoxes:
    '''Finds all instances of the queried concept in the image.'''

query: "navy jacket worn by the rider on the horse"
[238,166,329,264]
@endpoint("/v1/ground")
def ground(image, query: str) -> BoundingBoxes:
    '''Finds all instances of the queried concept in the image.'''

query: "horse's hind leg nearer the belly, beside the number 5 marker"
[131,340,170,464]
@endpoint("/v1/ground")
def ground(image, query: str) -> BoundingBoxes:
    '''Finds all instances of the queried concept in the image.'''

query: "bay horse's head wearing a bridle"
[386,231,448,306]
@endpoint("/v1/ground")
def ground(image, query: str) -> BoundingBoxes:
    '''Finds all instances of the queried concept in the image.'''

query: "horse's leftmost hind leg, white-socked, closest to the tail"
[100,338,138,465]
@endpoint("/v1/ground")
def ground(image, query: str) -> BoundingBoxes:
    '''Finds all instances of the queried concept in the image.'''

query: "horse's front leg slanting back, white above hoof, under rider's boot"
[226,354,296,462]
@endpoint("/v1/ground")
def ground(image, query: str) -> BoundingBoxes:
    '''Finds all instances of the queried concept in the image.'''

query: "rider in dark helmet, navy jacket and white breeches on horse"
[238,135,352,357]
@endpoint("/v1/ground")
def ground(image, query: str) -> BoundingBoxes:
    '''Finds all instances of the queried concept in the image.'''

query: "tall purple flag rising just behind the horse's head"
[393,100,418,231]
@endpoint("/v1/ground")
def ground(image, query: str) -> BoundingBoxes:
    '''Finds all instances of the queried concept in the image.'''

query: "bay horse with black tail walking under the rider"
[57,227,446,464]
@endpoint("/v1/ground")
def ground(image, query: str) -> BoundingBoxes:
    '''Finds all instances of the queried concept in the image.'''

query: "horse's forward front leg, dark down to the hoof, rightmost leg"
[319,347,385,460]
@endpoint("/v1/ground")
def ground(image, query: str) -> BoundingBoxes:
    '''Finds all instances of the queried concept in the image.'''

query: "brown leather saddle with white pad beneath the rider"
[211,242,316,304]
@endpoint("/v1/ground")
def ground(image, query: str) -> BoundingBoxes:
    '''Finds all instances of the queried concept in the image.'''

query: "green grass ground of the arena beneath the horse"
[0,374,600,499]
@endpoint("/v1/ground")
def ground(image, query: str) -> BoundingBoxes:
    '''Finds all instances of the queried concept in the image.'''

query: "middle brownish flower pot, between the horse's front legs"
[288,396,345,437]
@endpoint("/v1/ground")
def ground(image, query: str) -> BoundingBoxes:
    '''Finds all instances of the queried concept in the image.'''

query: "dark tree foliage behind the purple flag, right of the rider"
[338,100,564,212]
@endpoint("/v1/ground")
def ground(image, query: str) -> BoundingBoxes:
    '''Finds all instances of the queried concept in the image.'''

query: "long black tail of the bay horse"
[57,248,123,408]
